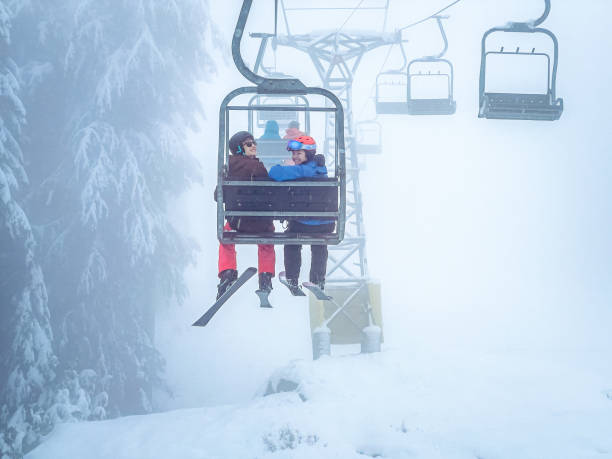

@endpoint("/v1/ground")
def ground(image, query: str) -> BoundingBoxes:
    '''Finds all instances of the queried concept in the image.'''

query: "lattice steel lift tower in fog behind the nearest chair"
[275,0,402,358]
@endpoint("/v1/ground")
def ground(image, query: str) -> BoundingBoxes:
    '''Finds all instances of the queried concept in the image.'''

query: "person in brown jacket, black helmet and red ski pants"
[217,131,276,299]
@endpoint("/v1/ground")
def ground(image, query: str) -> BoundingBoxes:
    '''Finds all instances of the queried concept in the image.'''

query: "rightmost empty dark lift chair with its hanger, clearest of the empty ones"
[478,0,563,121]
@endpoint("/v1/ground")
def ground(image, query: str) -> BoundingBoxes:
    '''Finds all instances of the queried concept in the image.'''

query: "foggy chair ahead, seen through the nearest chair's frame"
[249,95,310,169]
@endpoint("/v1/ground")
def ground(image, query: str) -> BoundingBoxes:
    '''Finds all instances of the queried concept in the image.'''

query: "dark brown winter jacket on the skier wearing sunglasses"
[228,155,274,233]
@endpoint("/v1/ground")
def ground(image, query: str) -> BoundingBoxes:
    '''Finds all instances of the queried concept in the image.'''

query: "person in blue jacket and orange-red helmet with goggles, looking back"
[268,135,335,296]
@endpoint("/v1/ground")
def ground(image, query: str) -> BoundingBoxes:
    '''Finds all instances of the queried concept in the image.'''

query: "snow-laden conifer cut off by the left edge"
[0,3,56,458]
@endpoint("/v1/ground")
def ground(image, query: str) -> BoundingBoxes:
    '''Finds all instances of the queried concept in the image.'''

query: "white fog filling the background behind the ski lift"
[156,0,612,408]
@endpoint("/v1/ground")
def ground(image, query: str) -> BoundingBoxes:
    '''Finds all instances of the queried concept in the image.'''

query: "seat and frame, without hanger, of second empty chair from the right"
[407,57,457,115]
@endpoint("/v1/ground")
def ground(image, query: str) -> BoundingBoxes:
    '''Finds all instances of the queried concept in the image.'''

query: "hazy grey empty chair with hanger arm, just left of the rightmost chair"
[407,16,456,115]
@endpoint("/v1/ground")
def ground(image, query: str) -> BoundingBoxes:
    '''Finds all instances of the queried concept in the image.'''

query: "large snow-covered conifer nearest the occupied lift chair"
[11,0,217,419]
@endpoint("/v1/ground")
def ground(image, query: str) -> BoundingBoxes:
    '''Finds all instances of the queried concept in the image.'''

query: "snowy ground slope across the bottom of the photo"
[27,349,612,459]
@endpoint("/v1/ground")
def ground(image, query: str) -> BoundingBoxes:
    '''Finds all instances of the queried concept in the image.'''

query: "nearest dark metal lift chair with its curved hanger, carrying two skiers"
[215,0,346,248]
